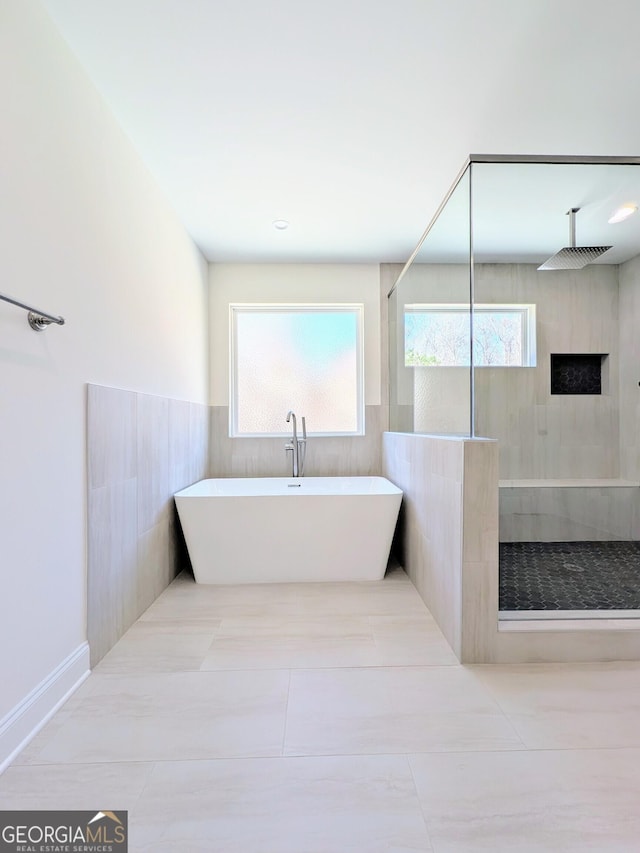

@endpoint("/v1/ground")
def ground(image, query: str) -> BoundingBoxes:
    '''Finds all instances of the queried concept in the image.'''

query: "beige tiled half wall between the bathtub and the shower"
[383,432,498,662]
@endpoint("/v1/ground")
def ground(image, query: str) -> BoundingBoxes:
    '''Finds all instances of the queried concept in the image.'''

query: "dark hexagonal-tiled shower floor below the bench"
[500,541,640,610]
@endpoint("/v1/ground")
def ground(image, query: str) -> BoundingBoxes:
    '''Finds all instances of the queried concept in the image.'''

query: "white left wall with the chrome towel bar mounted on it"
[0,0,208,748]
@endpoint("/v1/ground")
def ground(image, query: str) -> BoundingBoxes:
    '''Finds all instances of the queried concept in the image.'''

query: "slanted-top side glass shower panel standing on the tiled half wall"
[389,164,472,435]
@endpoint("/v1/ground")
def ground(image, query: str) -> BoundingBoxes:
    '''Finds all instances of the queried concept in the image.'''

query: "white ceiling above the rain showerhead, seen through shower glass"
[416,158,640,265]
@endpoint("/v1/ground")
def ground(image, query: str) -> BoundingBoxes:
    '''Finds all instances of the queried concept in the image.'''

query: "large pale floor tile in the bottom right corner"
[410,749,640,853]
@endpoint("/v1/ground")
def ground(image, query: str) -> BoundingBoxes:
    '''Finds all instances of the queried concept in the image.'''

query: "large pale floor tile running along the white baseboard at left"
[17,671,289,764]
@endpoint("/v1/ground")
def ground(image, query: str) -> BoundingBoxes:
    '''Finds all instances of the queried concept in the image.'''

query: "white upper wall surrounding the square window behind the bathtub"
[209,264,381,406]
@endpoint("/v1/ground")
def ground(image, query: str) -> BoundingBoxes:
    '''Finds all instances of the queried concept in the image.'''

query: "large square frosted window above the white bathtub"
[230,305,364,436]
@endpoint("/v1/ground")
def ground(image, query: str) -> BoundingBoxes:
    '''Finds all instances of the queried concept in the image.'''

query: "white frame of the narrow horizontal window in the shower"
[402,302,537,370]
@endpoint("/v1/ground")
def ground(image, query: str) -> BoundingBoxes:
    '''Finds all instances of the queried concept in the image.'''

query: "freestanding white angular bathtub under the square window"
[174,477,402,584]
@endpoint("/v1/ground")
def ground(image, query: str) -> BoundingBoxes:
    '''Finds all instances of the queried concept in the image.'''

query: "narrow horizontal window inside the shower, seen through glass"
[404,305,536,367]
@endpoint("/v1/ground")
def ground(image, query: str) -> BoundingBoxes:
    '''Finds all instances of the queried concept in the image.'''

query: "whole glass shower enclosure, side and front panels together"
[389,156,640,619]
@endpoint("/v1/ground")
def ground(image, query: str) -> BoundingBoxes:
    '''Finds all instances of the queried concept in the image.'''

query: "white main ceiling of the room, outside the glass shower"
[42,0,640,263]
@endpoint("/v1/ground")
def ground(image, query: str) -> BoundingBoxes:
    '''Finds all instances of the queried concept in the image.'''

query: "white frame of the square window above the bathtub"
[229,302,365,438]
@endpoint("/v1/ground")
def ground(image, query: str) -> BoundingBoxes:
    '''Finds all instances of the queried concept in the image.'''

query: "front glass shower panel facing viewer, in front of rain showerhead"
[471,162,640,617]
